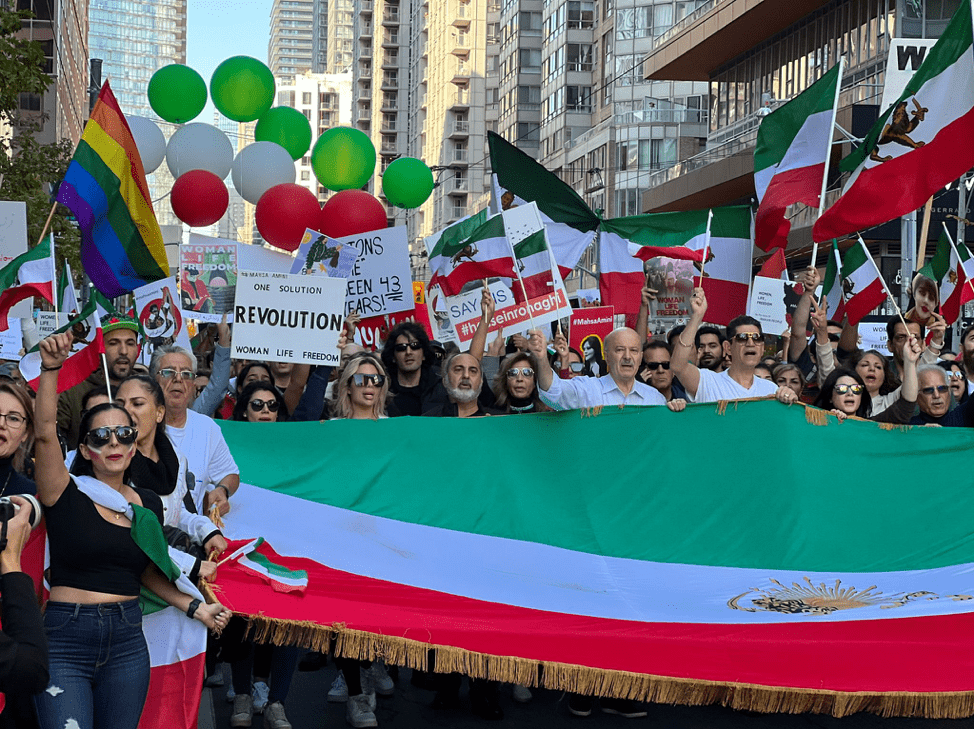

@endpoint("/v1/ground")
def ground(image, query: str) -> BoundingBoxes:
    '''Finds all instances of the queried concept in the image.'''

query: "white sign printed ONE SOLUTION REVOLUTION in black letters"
[231,270,345,365]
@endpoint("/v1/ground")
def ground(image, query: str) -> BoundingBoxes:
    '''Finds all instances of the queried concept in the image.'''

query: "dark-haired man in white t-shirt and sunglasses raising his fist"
[670,287,798,403]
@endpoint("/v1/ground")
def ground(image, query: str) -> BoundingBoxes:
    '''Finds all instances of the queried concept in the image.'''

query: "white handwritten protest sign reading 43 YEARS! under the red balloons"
[291,226,413,317]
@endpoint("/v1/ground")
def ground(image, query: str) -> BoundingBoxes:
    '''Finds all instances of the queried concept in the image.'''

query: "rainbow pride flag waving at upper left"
[57,81,169,297]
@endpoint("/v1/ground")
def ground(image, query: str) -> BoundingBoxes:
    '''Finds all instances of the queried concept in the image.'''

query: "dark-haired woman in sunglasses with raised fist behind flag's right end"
[815,337,922,425]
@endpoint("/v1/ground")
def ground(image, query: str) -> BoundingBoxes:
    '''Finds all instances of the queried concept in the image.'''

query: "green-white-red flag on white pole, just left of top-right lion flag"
[754,62,843,251]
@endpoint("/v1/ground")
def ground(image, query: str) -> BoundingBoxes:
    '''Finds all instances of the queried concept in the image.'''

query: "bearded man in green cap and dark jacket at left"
[57,314,139,450]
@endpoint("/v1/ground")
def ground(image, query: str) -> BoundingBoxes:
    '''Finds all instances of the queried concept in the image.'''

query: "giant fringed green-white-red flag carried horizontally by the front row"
[218,401,974,718]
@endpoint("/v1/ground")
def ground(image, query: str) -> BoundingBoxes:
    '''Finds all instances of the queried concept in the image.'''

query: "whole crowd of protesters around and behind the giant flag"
[0,269,974,729]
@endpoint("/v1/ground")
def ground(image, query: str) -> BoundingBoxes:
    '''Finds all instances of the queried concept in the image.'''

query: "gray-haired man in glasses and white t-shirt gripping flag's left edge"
[149,345,240,515]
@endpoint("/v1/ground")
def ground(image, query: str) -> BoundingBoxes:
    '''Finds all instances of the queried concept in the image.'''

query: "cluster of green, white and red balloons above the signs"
[127,56,434,250]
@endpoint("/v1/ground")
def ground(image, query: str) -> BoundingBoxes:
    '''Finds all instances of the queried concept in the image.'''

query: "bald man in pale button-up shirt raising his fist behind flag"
[528,327,686,410]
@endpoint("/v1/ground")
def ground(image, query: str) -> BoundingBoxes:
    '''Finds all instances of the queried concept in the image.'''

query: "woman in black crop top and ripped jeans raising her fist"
[35,333,230,729]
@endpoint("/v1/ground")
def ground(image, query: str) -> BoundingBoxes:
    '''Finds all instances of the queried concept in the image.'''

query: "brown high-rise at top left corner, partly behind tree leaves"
[13,0,89,144]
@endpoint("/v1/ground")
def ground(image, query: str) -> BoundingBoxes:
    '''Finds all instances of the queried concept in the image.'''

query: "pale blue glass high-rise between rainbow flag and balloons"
[88,0,186,230]
